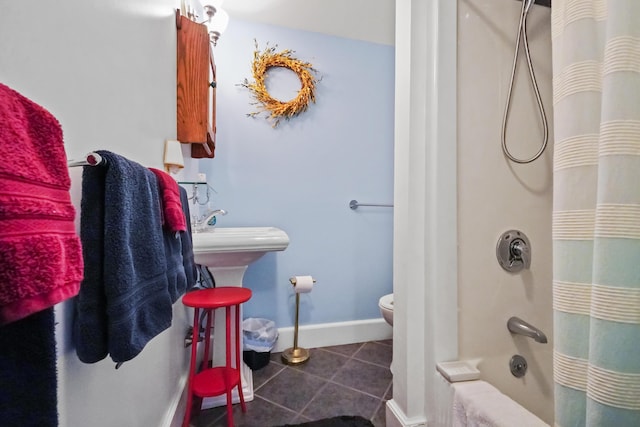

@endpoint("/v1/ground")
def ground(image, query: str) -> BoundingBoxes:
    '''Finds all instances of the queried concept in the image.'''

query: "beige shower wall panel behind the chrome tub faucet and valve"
[458,0,553,423]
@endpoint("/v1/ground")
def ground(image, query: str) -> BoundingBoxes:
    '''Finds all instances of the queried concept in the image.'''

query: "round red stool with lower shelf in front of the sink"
[182,286,251,427]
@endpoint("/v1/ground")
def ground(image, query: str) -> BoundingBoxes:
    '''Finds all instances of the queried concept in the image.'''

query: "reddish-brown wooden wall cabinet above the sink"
[176,11,216,158]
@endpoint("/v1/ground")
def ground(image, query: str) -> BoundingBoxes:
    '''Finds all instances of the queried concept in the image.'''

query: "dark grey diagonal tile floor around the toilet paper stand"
[191,340,392,427]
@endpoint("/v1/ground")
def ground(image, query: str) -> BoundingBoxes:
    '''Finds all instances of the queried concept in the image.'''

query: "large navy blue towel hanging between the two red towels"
[74,150,174,363]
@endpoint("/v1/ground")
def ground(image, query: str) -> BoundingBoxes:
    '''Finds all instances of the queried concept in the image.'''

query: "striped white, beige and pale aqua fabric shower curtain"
[551,0,640,427]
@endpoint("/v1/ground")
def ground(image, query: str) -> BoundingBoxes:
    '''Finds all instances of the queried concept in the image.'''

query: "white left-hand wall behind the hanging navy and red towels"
[0,0,188,427]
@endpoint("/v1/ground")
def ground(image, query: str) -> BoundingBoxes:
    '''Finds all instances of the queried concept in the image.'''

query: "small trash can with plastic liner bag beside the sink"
[242,317,278,371]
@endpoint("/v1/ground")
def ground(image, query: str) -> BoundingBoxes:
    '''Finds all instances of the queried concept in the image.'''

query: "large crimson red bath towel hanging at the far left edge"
[0,84,83,325]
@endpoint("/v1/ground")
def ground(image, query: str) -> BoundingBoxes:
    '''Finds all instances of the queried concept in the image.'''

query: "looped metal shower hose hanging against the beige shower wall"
[501,0,549,163]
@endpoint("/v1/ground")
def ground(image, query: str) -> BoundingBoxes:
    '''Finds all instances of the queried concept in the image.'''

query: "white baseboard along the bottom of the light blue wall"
[272,318,393,353]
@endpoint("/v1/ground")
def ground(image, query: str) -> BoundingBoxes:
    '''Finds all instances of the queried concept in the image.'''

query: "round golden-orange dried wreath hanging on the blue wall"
[239,41,318,128]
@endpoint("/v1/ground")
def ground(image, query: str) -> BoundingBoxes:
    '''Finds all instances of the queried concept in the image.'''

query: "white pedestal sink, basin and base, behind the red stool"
[192,227,289,409]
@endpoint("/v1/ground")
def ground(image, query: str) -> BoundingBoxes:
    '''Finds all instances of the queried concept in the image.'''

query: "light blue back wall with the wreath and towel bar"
[199,20,394,327]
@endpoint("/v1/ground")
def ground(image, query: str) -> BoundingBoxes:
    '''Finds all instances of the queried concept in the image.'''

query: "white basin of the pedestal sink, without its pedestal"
[193,227,289,270]
